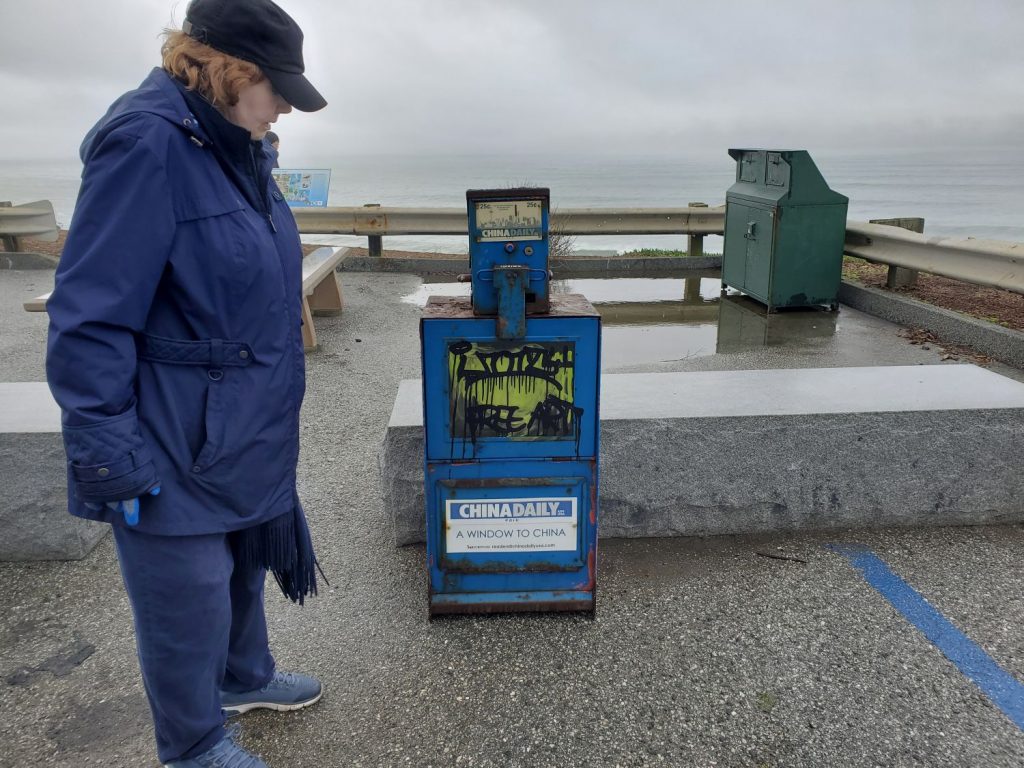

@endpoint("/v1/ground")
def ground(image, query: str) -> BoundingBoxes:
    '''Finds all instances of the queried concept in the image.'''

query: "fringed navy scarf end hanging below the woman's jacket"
[231,498,329,605]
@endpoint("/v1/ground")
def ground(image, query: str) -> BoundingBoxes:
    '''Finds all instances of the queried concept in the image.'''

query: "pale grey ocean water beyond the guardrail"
[0,147,1024,253]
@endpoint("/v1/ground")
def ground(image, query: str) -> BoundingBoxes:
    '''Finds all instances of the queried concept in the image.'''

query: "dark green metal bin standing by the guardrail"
[722,150,849,311]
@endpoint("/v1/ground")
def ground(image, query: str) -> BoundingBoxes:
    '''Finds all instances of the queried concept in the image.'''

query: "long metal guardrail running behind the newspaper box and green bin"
[294,203,1024,293]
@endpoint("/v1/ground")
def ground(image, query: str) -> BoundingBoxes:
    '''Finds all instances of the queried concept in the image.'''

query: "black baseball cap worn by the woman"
[181,0,327,112]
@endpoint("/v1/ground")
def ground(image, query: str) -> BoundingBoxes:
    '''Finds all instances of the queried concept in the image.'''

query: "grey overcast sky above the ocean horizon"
[0,0,1024,162]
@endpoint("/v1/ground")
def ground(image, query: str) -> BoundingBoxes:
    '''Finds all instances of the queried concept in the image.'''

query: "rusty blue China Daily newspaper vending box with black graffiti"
[420,188,601,615]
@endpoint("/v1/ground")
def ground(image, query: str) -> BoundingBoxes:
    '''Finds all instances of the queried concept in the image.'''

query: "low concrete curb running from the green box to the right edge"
[839,281,1024,369]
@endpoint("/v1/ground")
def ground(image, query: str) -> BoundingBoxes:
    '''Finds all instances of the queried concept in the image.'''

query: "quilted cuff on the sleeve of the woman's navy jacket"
[63,408,159,504]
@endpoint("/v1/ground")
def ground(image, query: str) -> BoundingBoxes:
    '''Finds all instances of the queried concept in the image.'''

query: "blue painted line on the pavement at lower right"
[828,544,1024,730]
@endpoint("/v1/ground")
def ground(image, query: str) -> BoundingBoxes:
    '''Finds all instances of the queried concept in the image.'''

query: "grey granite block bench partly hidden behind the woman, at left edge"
[0,382,110,560]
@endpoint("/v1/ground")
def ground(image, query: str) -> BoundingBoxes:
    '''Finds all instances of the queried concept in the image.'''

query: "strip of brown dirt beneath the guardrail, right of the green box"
[843,256,1024,331]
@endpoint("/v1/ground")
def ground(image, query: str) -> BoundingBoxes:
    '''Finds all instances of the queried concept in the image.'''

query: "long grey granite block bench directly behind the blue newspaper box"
[380,365,1024,546]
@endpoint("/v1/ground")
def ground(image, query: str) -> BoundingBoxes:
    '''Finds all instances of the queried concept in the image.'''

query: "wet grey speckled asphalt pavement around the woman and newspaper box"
[0,271,1024,768]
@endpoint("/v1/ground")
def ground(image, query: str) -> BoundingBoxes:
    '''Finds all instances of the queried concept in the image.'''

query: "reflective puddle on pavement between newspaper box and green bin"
[401,275,838,371]
